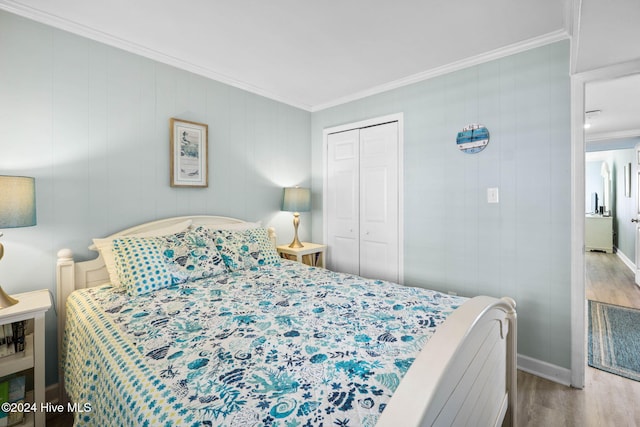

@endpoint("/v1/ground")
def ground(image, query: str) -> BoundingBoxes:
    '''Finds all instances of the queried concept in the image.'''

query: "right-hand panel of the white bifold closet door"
[360,122,398,282]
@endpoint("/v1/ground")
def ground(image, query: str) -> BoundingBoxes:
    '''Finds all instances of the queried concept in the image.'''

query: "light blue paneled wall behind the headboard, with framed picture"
[0,11,311,384]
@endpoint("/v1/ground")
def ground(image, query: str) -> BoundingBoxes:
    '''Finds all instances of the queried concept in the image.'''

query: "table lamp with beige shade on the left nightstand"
[0,175,36,309]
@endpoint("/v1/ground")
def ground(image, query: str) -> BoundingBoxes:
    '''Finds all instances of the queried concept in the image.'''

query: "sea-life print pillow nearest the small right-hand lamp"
[213,228,280,271]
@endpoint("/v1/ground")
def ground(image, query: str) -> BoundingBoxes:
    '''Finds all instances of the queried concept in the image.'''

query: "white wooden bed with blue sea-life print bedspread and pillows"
[57,216,517,426]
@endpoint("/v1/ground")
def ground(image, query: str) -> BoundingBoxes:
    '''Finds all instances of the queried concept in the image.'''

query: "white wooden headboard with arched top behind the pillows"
[56,215,277,403]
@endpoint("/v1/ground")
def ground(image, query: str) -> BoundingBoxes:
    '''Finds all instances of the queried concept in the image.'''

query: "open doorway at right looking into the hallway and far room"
[584,74,640,388]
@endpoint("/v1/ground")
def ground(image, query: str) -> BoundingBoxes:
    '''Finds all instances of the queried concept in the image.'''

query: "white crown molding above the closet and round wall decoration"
[311,30,569,112]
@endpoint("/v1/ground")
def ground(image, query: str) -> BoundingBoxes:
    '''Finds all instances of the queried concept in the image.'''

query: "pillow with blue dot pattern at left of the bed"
[113,237,178,295]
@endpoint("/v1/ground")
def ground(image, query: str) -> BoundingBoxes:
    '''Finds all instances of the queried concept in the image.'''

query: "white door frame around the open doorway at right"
[571,60,640,388]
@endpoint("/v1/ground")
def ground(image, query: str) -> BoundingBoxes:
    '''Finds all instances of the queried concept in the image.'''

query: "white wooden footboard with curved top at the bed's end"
[377,296,517,427]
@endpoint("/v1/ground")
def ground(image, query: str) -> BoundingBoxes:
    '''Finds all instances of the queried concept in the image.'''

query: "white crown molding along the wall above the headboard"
[0,0,311,111]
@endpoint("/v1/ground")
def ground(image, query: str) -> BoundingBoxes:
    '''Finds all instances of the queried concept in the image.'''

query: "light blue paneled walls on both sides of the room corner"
[0,12,571,384]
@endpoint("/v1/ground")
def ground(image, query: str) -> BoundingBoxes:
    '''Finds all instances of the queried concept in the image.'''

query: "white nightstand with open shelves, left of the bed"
[0,289,51,427]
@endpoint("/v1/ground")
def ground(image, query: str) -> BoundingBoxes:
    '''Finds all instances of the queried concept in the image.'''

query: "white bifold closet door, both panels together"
[327,122,399,282]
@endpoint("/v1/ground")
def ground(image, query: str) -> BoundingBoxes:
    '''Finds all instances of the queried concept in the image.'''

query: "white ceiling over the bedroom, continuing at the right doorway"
[0,0,640,135]
